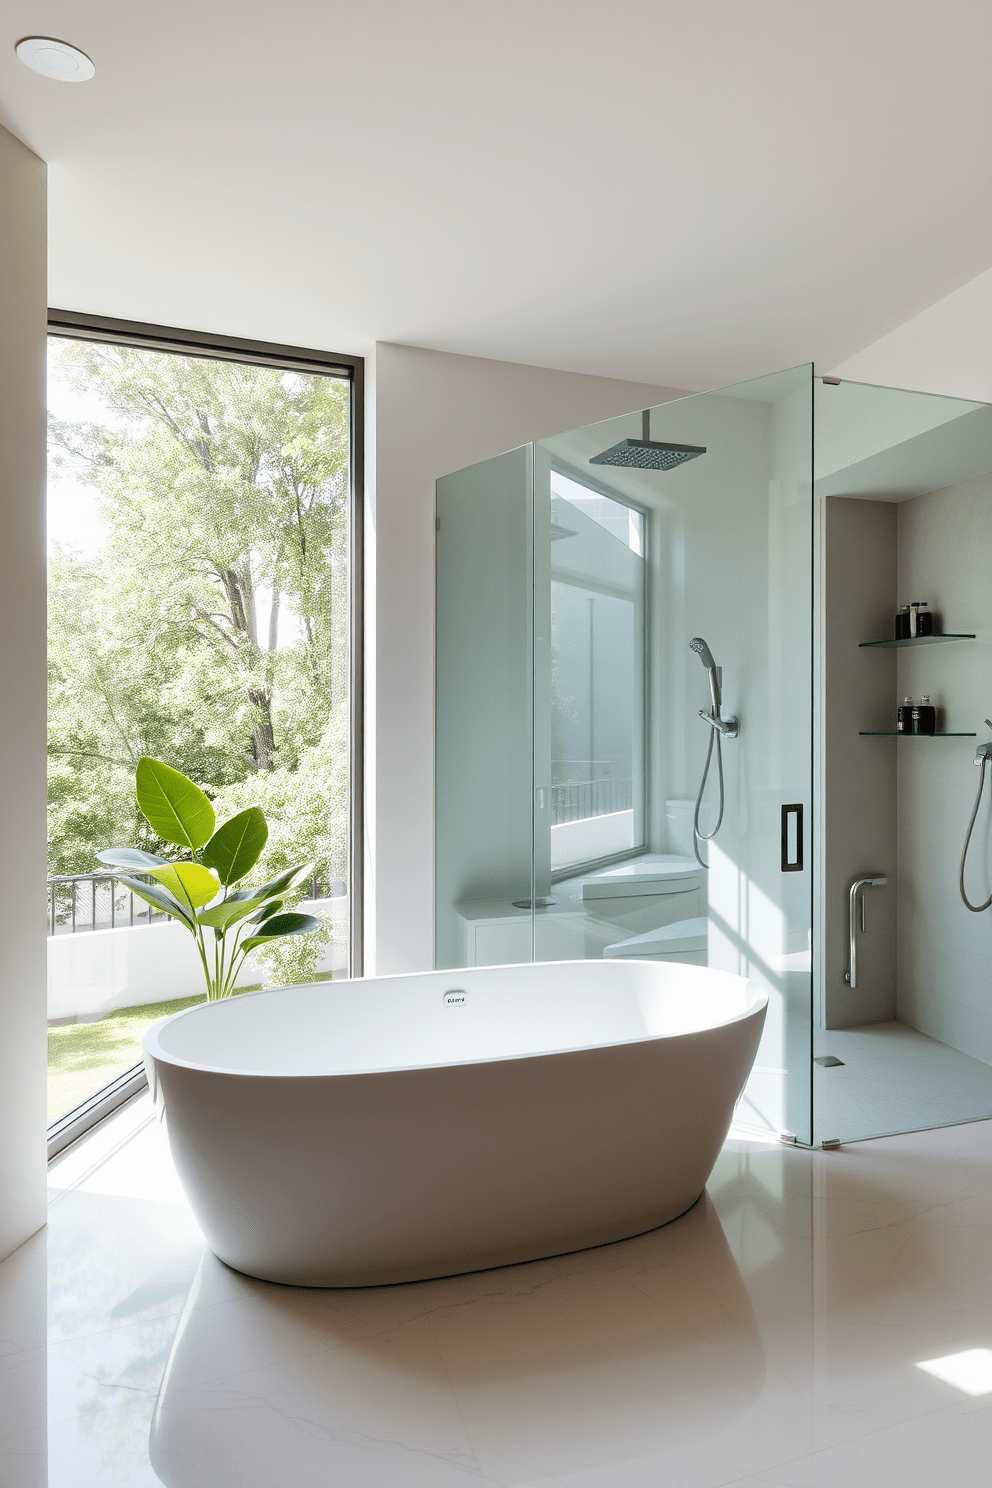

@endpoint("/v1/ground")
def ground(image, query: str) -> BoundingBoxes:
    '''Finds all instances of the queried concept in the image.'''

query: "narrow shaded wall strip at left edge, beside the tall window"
[0,128,48,1259]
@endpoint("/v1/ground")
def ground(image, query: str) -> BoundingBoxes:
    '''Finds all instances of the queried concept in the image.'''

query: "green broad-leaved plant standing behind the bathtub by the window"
[97,756,320,1001]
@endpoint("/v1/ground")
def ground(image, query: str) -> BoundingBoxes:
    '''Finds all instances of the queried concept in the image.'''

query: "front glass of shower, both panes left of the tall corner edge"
[436,366,814,1143]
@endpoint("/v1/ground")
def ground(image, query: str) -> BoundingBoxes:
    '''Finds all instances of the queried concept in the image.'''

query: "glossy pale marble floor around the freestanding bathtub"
[0,1101,992,1488]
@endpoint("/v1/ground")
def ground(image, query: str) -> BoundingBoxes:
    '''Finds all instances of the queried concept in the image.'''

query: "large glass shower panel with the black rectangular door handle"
[534,368,812,1143]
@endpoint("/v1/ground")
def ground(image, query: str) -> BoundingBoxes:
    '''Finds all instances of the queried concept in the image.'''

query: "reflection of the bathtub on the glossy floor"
[150,1196,764,1488]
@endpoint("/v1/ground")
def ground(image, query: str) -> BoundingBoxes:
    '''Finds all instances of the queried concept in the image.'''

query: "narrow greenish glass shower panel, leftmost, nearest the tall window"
[434,445,535,969]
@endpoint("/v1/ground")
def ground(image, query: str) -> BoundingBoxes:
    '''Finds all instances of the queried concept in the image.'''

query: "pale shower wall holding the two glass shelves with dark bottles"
[897,476,992,1064]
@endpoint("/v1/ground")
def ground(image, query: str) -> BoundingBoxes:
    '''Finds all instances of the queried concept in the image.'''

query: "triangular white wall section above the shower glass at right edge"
[833,269,992,403]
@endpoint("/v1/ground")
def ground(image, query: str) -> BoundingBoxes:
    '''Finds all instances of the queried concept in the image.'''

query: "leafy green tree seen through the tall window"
[49,341,350,940]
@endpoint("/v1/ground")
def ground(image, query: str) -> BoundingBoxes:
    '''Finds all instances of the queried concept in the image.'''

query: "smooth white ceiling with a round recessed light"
[0,0,992,388]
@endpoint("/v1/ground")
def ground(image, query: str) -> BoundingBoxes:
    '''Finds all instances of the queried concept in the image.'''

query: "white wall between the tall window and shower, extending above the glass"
[366,342,680,975]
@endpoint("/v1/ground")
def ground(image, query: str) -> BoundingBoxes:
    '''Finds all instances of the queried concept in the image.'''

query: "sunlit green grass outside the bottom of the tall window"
[48,972,332,1122]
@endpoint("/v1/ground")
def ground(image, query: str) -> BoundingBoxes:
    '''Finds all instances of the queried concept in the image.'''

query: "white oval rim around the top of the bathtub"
[141,957,769,1080]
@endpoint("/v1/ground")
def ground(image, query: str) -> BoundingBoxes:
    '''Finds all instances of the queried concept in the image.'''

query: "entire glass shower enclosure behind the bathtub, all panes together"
[434,366,992,1144]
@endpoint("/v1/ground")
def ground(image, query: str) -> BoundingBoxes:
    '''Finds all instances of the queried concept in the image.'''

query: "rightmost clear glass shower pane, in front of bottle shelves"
[814,372,992,1141]
